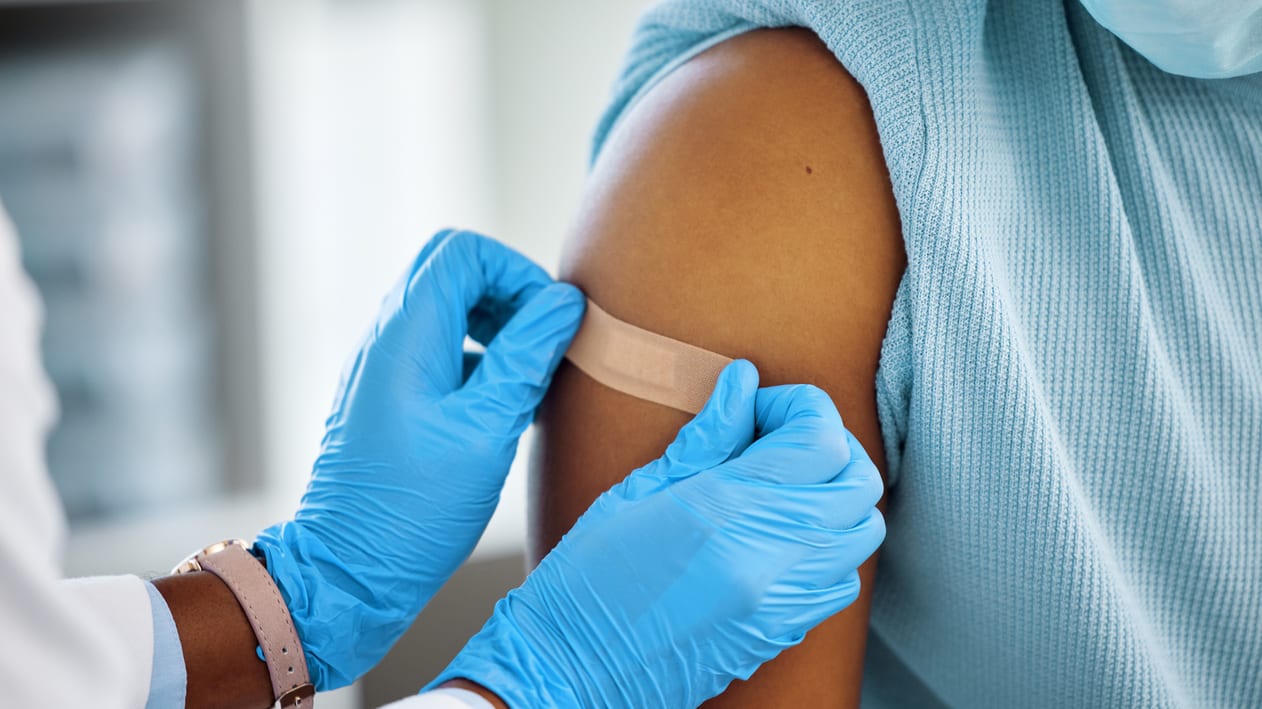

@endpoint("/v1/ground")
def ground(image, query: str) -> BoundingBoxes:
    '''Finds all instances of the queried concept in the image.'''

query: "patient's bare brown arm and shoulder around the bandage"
[530,29,906,706]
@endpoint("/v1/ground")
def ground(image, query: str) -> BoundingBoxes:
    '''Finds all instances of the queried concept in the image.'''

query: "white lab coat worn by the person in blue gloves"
[0,207,490,709]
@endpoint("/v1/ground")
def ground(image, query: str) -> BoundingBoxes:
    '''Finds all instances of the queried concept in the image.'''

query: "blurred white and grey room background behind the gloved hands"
[0,0,649,706]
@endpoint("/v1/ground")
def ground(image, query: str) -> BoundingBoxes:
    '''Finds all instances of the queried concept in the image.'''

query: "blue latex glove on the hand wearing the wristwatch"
[256,232,586,690]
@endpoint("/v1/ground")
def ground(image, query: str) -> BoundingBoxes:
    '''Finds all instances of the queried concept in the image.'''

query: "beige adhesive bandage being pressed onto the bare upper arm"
[565,299,732,414]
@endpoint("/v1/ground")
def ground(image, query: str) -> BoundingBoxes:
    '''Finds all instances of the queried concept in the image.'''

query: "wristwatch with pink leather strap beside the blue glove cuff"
[172,539,316,709]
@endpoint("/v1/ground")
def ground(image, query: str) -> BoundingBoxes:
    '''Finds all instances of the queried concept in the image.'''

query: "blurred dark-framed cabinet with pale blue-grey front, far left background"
[0,3,256,521]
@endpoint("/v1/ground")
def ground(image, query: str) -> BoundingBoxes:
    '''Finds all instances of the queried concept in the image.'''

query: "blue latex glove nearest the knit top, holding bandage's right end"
[430,361,885,709]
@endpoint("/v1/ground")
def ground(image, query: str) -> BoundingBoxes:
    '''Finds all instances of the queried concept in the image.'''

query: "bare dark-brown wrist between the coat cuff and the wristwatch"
[153,571,273,709]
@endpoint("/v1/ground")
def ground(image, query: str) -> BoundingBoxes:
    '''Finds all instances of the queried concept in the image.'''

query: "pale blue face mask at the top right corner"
[1082,0,1262,78]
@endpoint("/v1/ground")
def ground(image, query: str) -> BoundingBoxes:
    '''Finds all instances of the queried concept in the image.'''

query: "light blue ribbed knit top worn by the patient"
[596,0,1262,708]
